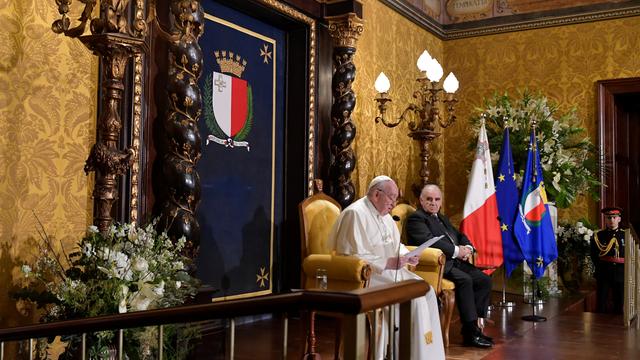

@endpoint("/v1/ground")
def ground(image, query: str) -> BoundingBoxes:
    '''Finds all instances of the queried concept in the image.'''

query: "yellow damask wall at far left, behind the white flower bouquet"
[0,0,98,328]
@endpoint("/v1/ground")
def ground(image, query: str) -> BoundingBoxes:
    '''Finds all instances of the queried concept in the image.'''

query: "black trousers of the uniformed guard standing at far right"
[596,261,624,314]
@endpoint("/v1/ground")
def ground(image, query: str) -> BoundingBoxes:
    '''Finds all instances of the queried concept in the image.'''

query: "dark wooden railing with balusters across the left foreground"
[0,280,429,360]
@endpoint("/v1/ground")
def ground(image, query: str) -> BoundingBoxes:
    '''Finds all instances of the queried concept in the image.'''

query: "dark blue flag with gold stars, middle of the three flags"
[496,128,524,276]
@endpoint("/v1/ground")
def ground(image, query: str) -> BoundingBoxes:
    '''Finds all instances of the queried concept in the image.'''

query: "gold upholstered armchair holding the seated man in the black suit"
[391,203,456,347]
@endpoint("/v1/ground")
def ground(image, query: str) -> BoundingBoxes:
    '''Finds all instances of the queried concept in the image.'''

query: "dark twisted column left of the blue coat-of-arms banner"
[160,0,204,256]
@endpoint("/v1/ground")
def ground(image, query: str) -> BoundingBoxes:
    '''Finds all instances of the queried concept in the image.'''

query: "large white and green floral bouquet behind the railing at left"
[14,222,198,359]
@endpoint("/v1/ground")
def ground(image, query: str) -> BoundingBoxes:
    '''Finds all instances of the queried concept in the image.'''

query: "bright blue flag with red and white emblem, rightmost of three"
[514,129,558,279]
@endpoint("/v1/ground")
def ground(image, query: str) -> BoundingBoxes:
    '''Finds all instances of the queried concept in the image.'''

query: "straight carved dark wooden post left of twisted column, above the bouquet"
[51,0,147,232]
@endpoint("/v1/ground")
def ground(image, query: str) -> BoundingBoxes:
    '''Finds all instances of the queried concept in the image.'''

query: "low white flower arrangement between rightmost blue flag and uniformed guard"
[557,221,594,286]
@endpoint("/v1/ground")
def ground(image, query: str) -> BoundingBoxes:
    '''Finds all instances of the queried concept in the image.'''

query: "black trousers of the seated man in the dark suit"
[444,259,491,323]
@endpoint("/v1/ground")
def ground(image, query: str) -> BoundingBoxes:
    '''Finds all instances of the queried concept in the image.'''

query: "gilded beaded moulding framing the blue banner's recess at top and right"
[260,0,317,196]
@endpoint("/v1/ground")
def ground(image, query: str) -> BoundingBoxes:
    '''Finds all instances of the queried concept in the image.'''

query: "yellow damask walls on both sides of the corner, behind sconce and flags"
[352,0,640,222]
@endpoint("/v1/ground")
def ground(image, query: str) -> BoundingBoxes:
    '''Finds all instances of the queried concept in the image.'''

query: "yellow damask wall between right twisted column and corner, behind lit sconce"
[351,0,444,199]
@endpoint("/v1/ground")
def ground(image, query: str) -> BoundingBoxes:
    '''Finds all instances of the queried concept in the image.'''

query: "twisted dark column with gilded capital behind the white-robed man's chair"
[327,13,364,208]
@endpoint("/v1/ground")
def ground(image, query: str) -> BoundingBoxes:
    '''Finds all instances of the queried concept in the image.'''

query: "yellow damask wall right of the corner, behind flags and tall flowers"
[444,17,640,225]
